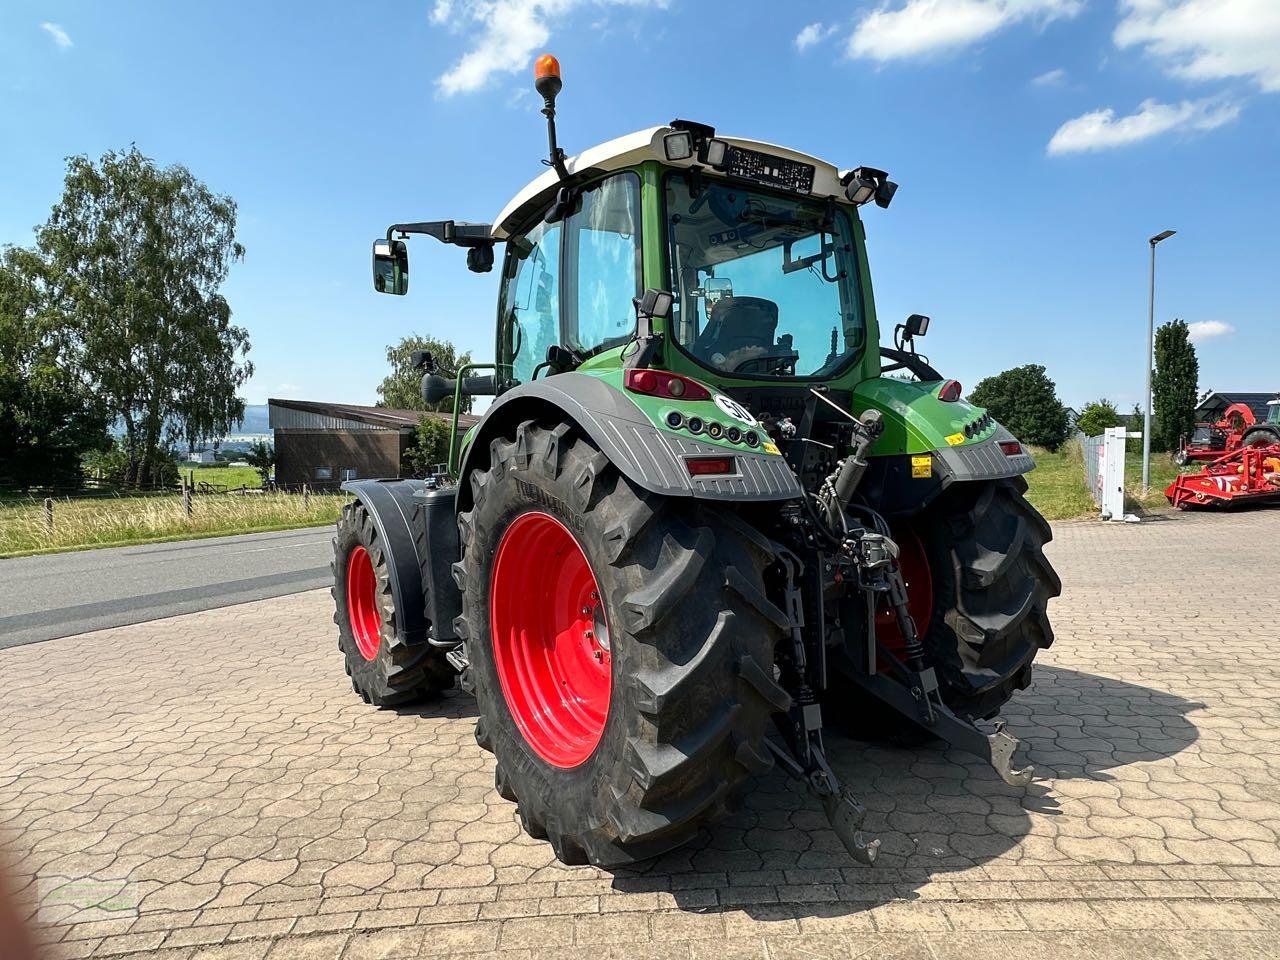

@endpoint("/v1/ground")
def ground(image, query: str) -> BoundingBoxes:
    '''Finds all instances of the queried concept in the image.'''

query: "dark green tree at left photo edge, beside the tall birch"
[0,247,110,488]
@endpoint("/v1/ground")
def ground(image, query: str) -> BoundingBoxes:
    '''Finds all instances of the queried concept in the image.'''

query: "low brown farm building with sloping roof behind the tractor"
[268,399,477,490]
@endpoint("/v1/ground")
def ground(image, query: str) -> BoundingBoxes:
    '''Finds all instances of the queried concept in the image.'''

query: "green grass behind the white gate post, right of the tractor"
[1027,442,1178,520]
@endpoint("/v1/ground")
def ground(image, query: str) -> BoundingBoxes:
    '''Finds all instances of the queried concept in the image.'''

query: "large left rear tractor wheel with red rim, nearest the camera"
[454,421,790,867]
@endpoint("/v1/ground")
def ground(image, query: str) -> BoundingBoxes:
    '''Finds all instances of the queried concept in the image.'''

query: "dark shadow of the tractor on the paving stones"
[613,666,1203,919]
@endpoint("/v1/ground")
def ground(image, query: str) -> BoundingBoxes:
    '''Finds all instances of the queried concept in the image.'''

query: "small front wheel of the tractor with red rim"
[330,502,457,707]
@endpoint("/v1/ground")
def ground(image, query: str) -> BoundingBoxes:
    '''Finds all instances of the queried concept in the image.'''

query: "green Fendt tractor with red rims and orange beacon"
[333,55,1060,867]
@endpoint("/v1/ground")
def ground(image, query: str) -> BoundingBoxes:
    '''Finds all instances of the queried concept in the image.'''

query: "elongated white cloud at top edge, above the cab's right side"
[849,0,1084,63]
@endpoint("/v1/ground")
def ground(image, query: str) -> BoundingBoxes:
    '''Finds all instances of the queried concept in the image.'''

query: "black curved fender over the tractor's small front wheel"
[342,480,430,644]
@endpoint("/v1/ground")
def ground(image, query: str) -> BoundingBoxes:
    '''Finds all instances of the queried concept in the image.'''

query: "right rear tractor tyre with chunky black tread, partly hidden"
[914,476,1062,719]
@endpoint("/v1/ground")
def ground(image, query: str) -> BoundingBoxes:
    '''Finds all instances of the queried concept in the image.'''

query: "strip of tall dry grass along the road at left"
[0,491,348,557]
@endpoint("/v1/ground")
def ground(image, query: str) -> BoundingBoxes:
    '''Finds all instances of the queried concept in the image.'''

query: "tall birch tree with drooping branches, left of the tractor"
[36,147,253,484]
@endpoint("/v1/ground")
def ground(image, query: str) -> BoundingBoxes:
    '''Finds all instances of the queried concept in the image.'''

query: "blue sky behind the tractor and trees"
[0,0,1280,408]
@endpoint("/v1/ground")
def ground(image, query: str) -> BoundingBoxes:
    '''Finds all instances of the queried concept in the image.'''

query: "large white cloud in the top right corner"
[1115,0,1280,93]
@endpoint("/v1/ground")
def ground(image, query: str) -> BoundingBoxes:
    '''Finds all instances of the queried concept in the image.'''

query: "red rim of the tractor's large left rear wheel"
[489,512,613,768]
